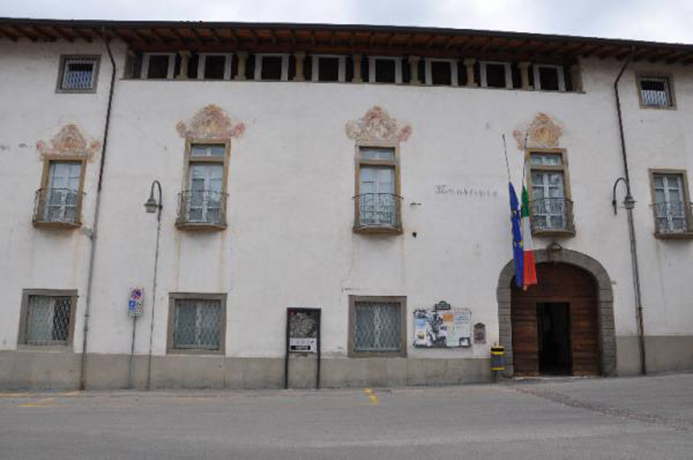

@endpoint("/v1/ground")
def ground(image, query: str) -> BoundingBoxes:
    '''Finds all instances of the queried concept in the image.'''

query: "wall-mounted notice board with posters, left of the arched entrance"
[414,301,472,348]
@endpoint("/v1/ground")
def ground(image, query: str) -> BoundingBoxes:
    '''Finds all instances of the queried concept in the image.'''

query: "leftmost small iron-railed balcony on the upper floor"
[32,188,84,228]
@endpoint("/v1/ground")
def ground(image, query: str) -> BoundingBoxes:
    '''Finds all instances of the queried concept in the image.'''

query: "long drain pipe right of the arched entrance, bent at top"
[614,48,647,375]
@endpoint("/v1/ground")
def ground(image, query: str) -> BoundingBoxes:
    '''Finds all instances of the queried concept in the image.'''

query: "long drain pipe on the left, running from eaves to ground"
[79,27,116,390]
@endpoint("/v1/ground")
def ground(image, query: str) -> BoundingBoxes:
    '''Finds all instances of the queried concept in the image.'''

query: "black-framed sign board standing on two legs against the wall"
[284,308,321,389]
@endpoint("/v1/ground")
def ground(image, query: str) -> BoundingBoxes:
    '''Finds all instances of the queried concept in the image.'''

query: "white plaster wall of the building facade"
[0,41,693,358]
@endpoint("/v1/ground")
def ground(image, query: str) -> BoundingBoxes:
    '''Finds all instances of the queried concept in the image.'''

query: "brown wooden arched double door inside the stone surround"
[511,263,601,376]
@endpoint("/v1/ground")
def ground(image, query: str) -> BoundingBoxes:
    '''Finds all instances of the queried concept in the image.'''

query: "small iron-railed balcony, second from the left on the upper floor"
[176,190,227,230]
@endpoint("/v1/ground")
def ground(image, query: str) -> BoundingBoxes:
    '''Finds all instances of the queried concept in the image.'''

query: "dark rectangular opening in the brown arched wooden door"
[537,302,572,375]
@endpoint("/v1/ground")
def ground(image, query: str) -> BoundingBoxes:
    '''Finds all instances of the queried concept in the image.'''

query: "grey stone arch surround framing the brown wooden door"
[496,248,616,377]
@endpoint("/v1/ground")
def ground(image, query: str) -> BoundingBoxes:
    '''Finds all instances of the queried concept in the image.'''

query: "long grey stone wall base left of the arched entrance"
[0,350,492,390]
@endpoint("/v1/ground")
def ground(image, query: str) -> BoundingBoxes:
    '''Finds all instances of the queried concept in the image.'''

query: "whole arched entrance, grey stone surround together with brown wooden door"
[497,245,616,377]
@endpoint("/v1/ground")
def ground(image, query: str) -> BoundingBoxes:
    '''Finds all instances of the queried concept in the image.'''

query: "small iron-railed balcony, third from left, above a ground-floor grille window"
[354,193,402,233]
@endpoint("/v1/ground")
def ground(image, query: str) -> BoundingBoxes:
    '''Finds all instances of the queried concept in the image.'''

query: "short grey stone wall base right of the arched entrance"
[616,335,693,376]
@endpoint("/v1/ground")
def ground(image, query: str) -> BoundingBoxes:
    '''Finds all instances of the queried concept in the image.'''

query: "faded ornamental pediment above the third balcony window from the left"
[346,105,412,142]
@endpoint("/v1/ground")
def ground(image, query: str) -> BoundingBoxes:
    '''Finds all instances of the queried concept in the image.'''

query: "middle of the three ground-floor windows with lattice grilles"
[168,294,226,354]
